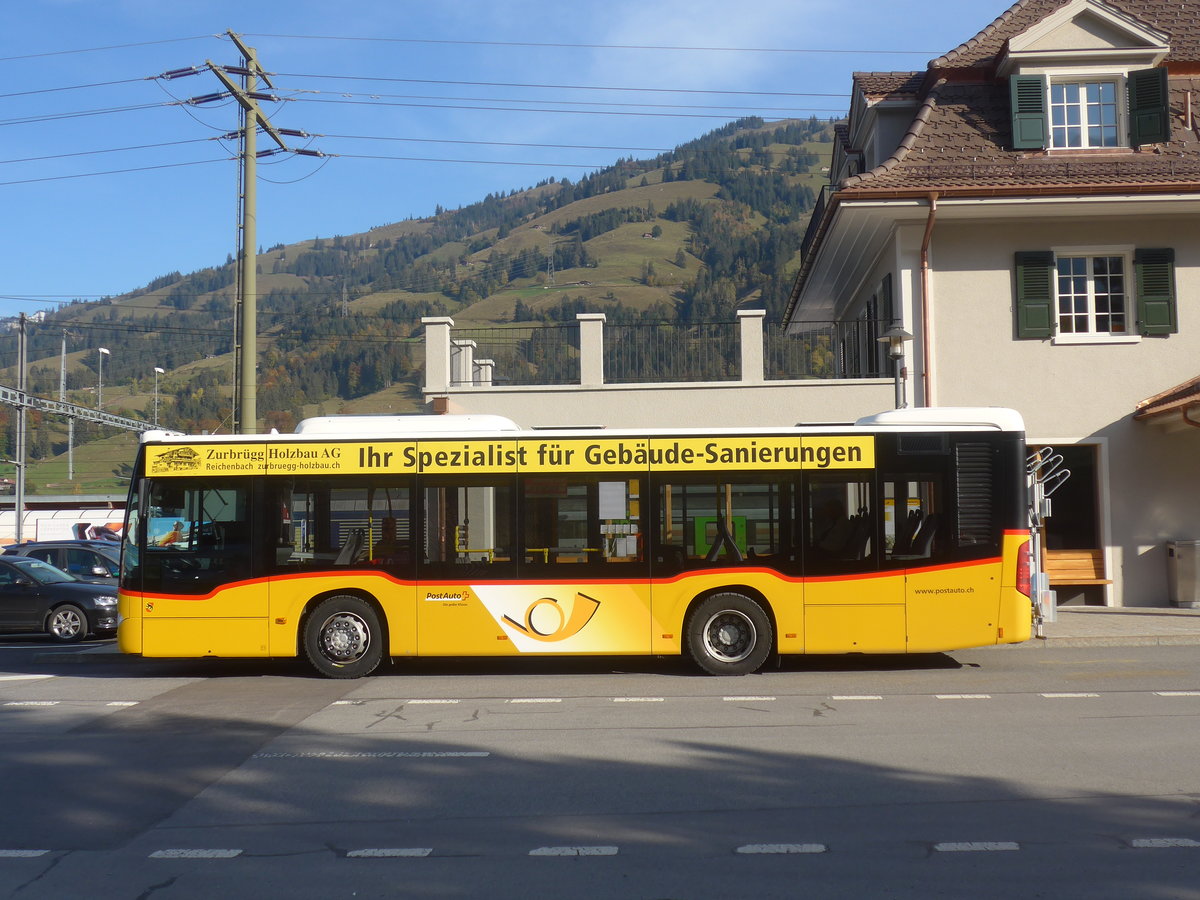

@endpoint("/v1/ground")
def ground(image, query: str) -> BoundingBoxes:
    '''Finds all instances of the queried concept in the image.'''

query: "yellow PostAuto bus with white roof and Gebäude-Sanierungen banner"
[119,409,1032,678]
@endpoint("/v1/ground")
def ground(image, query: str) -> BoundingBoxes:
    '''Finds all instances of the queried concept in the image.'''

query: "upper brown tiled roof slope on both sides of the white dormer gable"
[930,0,1200,68]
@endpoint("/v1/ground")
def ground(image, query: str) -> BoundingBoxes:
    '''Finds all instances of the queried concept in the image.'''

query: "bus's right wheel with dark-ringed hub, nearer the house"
[686,593,774,676]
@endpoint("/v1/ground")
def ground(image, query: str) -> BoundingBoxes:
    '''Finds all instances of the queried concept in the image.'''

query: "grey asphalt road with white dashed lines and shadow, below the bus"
[0,640,1200,900]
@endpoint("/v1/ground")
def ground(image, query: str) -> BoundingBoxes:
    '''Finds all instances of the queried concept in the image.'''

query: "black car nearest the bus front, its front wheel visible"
[0,553,116,643]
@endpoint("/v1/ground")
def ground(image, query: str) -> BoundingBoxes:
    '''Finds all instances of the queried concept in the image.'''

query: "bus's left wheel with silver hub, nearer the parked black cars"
[304,594,383,678]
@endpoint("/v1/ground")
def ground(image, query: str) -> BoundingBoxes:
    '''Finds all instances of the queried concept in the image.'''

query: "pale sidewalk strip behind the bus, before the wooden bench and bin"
[1030,606,1200,647]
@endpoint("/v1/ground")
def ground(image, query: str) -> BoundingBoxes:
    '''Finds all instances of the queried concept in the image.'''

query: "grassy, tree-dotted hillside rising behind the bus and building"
[0,119,833,493]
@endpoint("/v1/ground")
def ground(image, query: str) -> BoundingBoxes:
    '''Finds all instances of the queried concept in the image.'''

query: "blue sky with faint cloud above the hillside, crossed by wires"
[0,0,1007,317]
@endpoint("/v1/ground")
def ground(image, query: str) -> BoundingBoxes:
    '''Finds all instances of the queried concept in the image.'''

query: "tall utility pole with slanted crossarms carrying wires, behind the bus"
[205,30,288,434]
